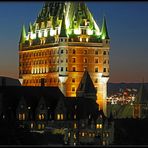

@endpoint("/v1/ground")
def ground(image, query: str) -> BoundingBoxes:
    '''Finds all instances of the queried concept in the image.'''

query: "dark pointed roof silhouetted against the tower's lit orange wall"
[77,70,96,94]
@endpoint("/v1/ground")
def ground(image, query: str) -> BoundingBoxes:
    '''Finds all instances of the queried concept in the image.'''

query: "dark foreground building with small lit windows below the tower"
[0,71,114,145]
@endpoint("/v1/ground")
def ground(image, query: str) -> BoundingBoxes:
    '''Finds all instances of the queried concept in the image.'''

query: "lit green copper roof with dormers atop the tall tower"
[21,1,109,43]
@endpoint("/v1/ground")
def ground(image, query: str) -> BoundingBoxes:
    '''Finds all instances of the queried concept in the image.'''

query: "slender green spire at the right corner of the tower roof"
[101,16,109,39]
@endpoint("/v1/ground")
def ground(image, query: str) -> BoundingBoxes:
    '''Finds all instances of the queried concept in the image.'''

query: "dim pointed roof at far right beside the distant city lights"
[135,83,148,104]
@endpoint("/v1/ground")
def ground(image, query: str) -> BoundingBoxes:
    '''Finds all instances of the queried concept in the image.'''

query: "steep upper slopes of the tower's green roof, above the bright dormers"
[35,1,100,36]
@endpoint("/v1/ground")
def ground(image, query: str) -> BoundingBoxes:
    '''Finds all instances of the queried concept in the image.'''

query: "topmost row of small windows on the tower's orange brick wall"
[20,49,109,58]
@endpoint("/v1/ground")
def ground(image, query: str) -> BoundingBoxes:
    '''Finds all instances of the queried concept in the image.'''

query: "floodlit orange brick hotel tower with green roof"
[19,2,110,113]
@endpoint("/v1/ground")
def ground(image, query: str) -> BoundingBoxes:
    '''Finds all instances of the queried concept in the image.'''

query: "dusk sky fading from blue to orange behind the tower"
[0,2,148,82]
